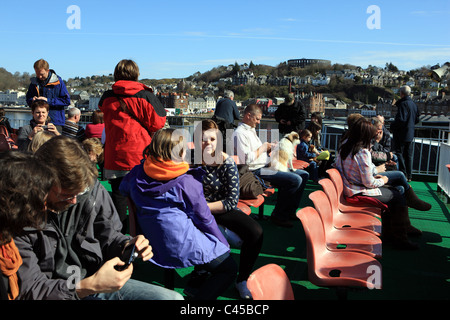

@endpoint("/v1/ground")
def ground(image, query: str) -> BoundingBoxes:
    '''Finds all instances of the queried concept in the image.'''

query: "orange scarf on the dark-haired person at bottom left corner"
[0,239,22,300]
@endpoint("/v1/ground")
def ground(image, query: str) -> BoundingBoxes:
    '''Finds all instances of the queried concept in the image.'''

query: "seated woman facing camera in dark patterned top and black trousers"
[194,119,263,299]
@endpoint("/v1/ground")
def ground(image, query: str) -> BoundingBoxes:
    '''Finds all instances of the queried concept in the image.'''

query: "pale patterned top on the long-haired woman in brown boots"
[335,149,384,197]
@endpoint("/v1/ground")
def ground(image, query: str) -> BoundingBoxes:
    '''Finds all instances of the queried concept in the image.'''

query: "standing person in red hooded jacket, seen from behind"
[99,60,166,232]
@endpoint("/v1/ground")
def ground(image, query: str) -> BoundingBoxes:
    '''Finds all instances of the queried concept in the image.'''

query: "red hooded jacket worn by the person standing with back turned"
[99,80,166,171]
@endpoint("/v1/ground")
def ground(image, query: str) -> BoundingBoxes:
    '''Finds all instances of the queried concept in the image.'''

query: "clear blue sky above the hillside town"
[0,0,450,79]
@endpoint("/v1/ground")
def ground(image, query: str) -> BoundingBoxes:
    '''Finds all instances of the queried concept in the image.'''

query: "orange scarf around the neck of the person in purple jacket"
[144,157,189,181]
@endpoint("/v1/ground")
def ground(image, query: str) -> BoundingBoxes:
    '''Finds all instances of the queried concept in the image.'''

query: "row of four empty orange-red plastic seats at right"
[297,168,382,298]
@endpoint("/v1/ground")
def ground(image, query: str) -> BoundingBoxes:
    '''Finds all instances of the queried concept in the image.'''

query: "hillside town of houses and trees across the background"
[0,59,450,121]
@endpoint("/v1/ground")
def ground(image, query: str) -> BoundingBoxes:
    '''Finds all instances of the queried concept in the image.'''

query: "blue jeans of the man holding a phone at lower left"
[89,279,184,300]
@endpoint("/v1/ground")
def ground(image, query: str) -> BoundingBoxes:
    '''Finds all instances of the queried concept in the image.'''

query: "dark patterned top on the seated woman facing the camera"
[203,157,239,211]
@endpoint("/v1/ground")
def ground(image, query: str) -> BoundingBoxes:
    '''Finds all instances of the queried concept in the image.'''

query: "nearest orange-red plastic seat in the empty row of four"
[297,207,382,296]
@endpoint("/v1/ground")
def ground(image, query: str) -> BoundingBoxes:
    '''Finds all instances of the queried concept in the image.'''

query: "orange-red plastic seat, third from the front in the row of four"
[318,179,382,236]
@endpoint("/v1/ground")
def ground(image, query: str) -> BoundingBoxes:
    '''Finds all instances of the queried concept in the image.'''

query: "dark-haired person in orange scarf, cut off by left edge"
[0,151,56,300]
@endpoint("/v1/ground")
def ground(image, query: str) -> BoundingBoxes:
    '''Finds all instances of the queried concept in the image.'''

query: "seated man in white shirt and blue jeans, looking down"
[228,104,309,227]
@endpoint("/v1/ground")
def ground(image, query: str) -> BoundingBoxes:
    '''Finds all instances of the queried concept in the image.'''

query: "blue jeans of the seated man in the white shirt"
[253,168,309,220]
